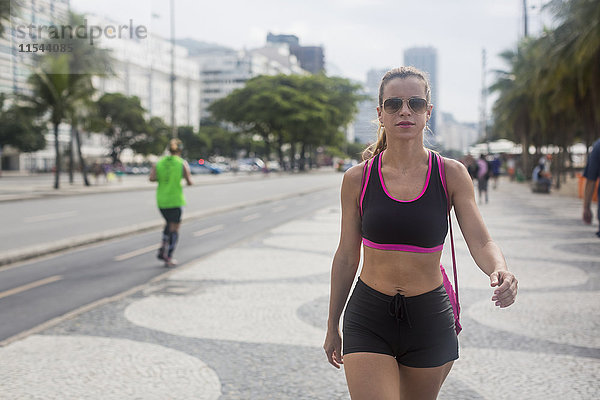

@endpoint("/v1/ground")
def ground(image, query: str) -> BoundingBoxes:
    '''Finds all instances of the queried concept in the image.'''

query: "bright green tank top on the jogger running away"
[156,156,185,208]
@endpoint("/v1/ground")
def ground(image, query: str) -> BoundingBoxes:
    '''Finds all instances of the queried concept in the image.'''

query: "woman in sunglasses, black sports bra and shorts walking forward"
[323,67,517,400]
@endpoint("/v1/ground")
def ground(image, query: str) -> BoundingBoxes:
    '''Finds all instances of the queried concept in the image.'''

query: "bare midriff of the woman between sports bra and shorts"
[360,246,443,297]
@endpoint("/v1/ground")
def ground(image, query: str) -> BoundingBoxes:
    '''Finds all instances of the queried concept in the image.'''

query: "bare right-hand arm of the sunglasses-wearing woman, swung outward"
[444,159,518,308]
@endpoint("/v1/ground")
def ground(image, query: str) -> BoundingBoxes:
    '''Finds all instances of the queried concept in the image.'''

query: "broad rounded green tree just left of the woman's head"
[209,75,362,168]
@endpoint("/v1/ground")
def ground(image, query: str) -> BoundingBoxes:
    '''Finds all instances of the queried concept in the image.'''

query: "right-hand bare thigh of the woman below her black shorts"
[398,361,454,400]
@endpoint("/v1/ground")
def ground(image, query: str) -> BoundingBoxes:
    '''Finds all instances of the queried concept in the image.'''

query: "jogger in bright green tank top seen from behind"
[150,139,192,267]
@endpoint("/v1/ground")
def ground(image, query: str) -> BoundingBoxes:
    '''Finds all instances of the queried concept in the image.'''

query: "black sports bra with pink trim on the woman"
[360,151,448,253]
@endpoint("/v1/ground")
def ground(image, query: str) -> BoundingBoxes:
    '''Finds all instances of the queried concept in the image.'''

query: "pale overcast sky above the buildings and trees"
[71,0,548,122]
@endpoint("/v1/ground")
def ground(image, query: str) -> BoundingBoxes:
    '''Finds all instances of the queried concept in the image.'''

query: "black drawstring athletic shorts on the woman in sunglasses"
[343,278,458,368]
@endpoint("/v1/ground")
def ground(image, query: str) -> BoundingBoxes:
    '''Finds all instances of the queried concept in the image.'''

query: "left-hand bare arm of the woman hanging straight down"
[323,164,363,368]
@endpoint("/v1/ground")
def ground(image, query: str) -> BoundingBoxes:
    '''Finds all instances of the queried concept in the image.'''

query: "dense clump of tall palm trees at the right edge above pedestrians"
[491,0,600,180]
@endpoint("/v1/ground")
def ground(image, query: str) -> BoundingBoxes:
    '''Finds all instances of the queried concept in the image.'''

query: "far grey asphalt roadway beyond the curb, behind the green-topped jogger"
[0,172,341,265]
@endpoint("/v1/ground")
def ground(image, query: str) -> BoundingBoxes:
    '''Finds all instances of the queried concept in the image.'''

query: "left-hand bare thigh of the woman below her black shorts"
[344,353,400,400]
